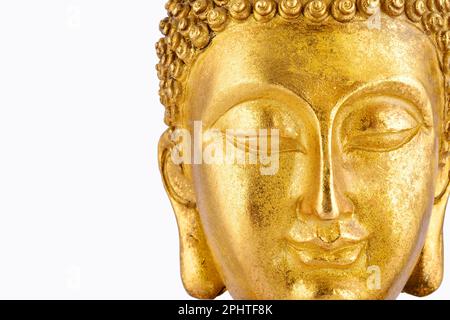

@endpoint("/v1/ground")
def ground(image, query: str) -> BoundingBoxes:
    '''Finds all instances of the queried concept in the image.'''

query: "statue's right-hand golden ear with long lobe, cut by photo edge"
[404,148,450,297]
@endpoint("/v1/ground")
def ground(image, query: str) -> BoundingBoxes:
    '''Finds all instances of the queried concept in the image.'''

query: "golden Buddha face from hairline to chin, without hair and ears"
[160,11,445,299]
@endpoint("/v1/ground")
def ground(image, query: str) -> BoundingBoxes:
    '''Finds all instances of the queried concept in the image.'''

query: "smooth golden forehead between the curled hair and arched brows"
[184,16,443,126]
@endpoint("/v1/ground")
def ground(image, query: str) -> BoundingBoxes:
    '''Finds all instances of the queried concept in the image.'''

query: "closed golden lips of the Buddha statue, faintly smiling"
[288,239,366,268]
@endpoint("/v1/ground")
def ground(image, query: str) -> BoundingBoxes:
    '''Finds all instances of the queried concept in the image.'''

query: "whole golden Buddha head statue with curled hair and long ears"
[156,0,450,299]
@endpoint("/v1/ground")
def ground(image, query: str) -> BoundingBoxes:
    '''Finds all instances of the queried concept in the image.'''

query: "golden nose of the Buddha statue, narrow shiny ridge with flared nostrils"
[298,135,354,220]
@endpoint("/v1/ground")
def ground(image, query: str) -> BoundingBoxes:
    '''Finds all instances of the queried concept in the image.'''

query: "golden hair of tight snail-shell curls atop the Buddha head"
[157,0,450,127]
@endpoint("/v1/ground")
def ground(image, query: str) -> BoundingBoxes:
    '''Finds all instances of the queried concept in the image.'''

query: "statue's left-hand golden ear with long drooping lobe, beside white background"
[158,129,225,299]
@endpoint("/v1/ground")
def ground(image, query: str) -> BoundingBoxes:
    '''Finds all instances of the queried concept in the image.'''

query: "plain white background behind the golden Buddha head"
[0,0,450,299]
